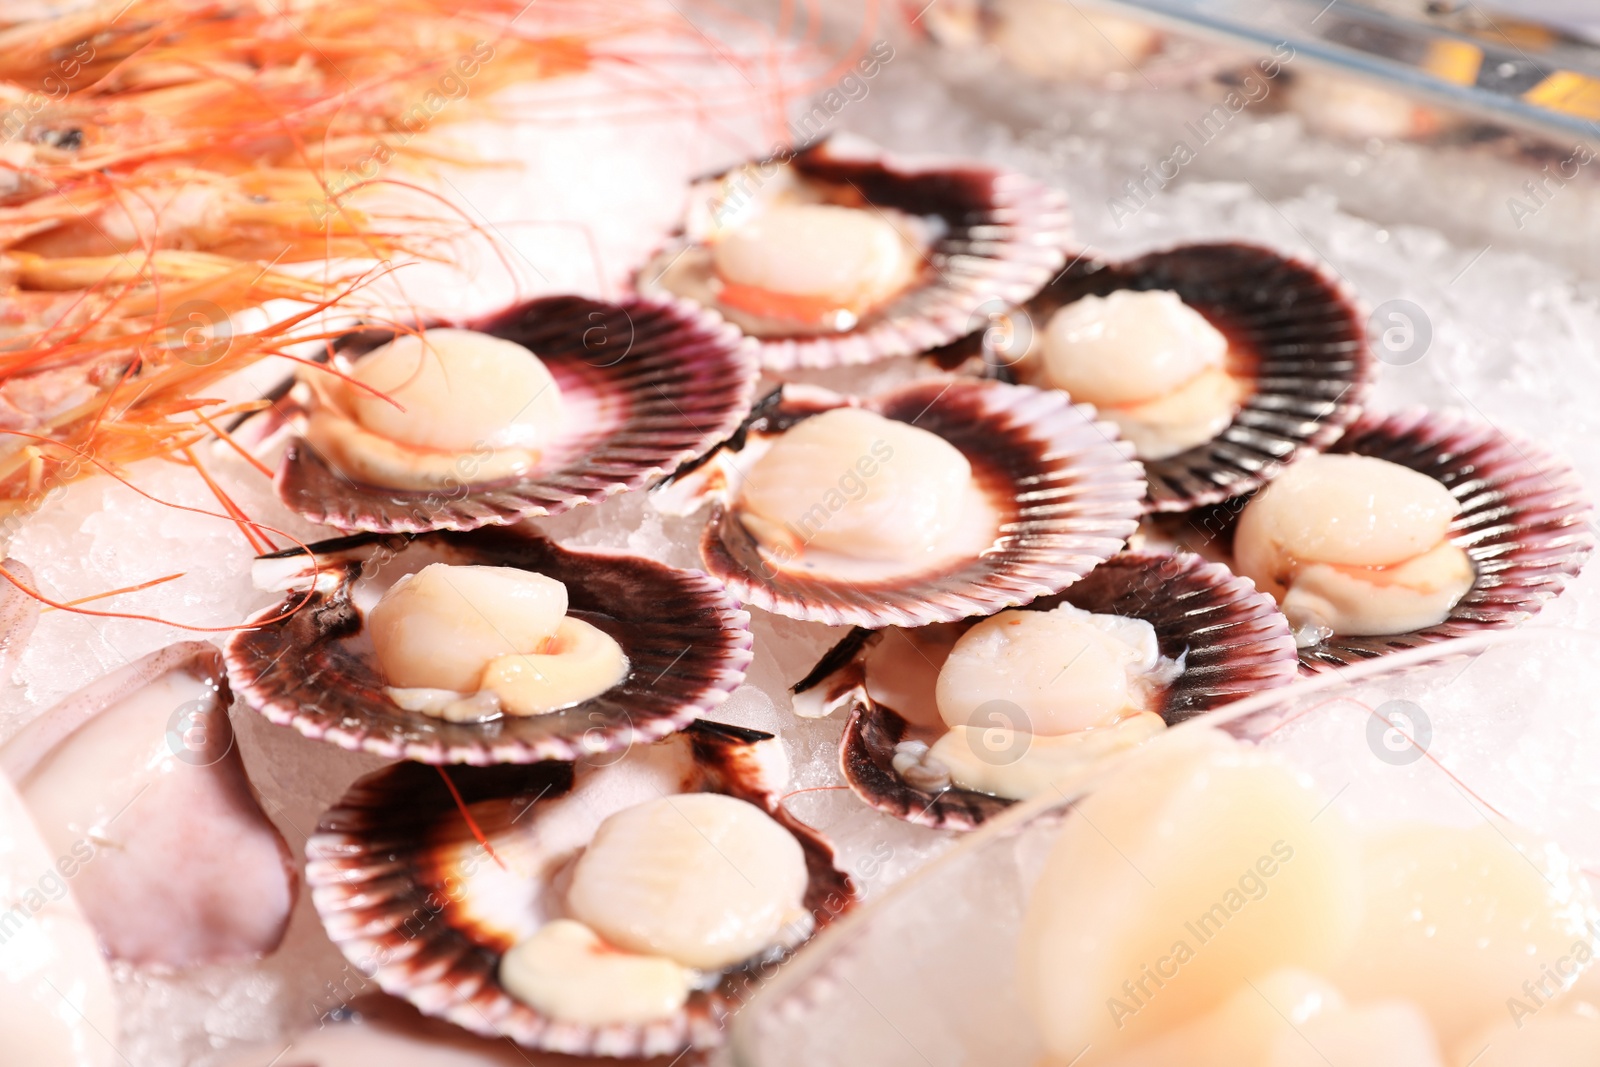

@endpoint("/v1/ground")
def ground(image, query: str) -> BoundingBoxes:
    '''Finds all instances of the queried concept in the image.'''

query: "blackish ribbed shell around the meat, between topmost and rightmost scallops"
[933,243,1376,512]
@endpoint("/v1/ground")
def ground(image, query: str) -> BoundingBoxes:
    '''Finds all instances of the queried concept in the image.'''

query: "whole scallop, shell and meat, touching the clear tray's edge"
[795,552,1298,830]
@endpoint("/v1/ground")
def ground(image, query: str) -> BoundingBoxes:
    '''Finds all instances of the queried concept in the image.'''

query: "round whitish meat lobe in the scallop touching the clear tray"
[934,605,1160,734]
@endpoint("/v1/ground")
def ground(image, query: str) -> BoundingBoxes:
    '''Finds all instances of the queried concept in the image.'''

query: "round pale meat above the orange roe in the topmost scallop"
[712,203,909,307]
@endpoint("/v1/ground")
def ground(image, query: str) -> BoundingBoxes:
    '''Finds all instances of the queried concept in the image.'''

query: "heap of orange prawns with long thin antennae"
[0,0,851,521]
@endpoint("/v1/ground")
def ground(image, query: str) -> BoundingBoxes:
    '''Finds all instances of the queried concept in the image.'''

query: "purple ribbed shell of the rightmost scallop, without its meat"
[1301,408,1595,673]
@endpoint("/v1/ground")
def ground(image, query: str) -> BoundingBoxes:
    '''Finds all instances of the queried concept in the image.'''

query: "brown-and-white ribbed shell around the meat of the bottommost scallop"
[306,720,856,1056]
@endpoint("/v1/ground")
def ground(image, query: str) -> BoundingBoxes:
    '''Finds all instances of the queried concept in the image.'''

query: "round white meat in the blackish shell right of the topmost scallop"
[1043,290,1227,406]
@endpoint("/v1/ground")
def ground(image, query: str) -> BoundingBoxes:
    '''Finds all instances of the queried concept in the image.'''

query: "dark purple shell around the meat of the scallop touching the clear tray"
[795,552,1298,830]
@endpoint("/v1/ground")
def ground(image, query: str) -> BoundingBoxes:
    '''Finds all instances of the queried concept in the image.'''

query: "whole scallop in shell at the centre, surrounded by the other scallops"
[656,378,1144,627]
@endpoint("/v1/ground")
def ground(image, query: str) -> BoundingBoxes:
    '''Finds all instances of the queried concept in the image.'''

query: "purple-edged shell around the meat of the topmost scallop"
[638,138,1070,371]
